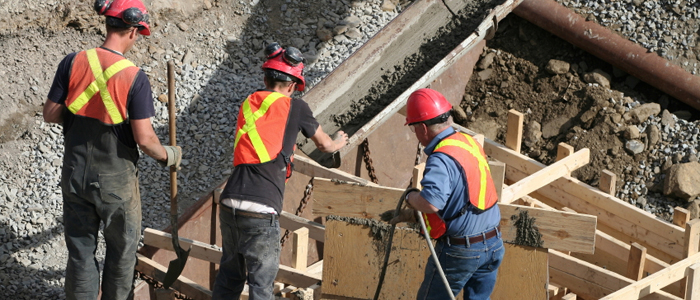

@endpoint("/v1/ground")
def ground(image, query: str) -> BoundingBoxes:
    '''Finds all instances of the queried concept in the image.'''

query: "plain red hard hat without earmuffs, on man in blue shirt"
[404,89,452,125]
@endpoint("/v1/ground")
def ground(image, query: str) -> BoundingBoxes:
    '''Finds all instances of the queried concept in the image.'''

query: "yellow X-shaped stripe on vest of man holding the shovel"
[68,49,135,124]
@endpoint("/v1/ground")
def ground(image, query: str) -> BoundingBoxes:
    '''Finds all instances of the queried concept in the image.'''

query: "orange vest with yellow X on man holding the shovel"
[65,48,139,125]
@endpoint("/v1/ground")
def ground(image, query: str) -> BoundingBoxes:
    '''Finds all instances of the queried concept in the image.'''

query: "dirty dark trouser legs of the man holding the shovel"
[61,168,141,300]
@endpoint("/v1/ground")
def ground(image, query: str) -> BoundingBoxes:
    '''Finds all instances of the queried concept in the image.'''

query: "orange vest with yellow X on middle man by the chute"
[233,91,292,168]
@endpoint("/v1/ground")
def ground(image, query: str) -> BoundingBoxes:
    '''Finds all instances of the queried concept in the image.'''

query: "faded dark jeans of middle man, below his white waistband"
[212,206,280,300]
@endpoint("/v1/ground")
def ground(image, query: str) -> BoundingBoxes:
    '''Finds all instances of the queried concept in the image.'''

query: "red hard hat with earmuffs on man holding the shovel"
[95,0,151,35]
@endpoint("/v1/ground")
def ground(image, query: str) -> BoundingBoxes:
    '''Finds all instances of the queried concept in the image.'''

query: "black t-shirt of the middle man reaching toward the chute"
[221,90,319,213]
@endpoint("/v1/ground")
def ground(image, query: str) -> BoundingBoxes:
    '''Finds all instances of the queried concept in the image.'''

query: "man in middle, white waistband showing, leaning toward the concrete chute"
[212,43,348,300]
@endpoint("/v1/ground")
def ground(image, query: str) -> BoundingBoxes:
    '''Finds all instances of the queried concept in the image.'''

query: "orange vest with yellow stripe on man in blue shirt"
[423,133,498,239]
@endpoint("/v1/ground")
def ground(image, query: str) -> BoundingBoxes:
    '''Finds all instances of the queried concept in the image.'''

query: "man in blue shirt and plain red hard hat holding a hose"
[391,89,505,300]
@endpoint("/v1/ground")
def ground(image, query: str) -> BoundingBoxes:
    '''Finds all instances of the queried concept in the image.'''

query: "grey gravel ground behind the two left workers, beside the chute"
[0,0,401,300]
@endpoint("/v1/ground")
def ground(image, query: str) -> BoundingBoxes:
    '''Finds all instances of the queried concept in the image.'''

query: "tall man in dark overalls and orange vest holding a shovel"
[44,0,181,300]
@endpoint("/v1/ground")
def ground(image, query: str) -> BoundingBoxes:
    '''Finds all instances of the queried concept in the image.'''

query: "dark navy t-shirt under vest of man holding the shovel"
[48,48,156,148]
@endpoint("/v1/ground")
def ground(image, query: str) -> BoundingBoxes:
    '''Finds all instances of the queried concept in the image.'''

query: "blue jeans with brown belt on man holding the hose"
[416,232,505,300]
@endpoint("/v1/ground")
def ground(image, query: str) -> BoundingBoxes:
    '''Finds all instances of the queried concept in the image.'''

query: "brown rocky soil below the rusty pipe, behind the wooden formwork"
[461,14,697,195]
